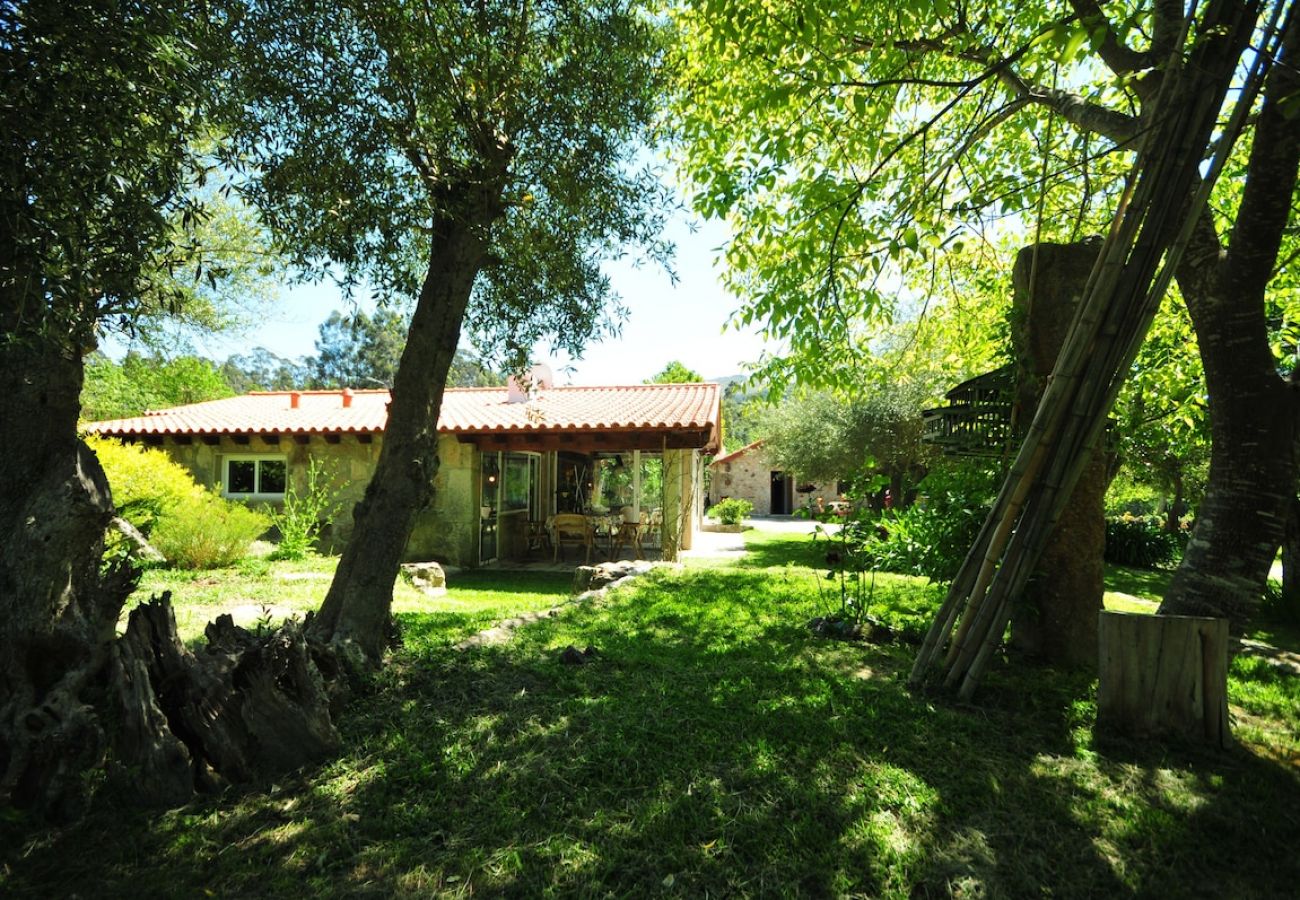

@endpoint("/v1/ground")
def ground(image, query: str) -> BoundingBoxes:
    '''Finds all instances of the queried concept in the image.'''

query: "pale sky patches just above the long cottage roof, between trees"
[183,213,764,385]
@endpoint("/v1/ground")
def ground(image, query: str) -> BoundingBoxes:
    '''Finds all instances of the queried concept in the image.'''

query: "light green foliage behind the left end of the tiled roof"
[81,352,235,421]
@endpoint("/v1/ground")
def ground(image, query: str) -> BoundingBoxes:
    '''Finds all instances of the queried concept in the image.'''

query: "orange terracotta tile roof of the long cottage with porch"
[86,382,720,447]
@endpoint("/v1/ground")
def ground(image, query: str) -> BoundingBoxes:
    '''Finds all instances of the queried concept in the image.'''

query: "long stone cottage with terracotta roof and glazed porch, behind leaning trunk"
[85,384,720,566]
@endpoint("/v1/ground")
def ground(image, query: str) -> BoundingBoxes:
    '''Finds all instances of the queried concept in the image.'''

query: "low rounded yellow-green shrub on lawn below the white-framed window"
[150,490,269,568]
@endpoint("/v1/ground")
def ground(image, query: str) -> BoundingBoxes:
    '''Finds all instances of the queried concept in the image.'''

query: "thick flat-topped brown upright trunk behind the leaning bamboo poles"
[1011,241,1108,666]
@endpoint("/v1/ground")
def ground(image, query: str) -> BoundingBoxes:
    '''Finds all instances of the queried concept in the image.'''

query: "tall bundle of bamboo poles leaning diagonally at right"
[910,0,1283,698]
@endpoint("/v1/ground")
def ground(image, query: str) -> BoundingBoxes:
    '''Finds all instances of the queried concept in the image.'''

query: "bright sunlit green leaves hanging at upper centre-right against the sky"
[673,0,1132,388]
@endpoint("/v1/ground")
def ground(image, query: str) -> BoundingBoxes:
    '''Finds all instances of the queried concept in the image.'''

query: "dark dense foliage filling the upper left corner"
[0,0,236,354]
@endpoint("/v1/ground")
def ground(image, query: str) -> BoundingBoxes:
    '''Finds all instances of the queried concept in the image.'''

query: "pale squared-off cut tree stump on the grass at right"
[1097,611,1232,748]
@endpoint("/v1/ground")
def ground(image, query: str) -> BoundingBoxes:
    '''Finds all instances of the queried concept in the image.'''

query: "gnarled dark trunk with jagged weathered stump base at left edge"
[0,330,337,821]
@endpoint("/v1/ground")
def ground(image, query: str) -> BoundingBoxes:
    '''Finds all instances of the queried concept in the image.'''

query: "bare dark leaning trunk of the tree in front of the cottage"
[312,185,502,667]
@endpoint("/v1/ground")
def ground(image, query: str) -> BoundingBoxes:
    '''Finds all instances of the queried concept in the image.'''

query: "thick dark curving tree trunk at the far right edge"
[1160,16,1300,631]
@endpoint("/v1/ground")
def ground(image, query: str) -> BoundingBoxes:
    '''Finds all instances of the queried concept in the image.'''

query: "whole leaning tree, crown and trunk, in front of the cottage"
[229,0,664,662]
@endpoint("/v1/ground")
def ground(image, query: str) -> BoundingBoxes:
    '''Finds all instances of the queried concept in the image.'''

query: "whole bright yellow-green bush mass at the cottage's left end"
[87,437,269,568]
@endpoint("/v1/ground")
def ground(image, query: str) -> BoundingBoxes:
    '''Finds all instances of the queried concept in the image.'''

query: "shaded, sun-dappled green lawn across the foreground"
[0,535,1300,897]
